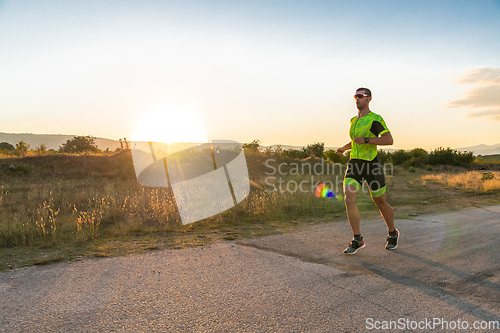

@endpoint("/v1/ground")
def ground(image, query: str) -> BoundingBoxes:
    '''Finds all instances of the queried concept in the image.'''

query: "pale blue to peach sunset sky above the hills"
[0,0,500,149]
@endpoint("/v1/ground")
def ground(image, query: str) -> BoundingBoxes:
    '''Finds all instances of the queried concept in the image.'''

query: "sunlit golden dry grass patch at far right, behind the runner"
[422,171,500,192]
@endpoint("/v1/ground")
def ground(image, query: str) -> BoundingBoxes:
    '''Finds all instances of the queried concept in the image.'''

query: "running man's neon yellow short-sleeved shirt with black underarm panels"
[349,112,389,161]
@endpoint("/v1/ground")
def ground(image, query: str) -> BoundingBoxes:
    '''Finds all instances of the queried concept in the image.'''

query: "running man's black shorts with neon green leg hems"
[344,157,385,197]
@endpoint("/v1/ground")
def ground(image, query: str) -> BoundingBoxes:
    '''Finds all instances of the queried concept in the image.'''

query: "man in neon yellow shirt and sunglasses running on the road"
[336,88,399,254]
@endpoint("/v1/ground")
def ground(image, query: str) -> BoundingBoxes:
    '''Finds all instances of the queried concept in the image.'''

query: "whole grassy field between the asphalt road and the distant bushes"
[0,151,500,271]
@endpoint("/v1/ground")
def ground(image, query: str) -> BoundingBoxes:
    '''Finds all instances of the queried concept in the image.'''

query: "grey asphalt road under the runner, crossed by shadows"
[0,206,500,332]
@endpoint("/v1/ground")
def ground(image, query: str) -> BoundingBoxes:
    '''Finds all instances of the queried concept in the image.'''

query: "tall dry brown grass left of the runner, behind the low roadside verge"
[0,152,343,248]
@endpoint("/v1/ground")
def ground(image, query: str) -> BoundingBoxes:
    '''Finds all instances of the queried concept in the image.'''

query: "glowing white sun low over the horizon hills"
[130,104,208,144]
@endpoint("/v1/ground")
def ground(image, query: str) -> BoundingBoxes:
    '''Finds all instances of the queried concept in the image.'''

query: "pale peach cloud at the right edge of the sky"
[447,68,500,121]
